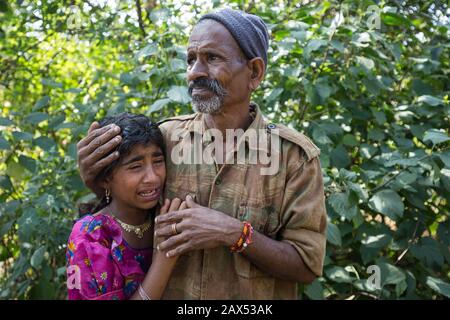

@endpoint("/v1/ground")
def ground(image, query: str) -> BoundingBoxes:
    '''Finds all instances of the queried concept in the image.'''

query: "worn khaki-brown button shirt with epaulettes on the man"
[156,104,327,299]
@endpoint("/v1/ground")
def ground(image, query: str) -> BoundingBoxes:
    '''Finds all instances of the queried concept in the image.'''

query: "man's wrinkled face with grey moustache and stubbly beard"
[187,20,250,114]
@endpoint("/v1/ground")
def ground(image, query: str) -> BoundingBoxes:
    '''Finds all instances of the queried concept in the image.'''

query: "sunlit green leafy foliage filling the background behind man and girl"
[0,0,450,299]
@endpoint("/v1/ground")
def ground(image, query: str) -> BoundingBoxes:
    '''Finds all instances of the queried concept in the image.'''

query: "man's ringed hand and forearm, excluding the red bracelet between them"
[155,196,316,283]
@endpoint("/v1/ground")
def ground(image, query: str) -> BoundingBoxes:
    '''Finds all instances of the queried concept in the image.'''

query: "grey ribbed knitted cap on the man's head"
[199,8,269,68]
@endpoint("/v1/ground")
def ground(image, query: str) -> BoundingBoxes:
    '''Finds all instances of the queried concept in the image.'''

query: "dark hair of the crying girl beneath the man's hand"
[78,112,165,217]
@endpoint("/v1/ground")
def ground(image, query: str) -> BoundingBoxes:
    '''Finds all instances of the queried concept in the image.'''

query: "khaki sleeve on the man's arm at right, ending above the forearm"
[280,157,327,276]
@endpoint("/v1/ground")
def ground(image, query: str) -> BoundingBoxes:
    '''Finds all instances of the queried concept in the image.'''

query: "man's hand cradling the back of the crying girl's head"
[77,122,122,195]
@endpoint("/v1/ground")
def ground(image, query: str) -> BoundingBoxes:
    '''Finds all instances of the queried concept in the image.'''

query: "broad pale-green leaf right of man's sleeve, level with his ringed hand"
[369,189,405,220]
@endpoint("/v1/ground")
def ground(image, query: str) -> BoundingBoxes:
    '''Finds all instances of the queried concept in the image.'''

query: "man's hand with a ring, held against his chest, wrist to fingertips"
[155,196,242,257]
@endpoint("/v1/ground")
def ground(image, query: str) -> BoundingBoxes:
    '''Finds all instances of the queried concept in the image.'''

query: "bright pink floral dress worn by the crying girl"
[66,214,153,300]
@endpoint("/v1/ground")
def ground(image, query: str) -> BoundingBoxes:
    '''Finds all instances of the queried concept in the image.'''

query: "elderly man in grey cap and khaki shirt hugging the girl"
[78,9,326,299]
